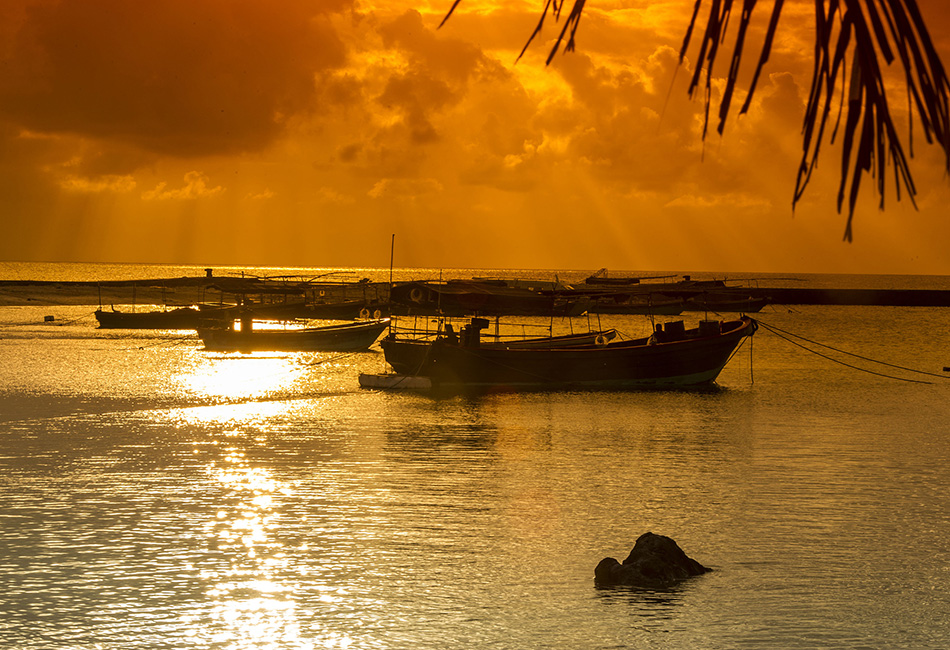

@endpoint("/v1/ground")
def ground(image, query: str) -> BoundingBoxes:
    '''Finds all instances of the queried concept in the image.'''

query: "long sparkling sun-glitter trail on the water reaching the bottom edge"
[182,438,356,650]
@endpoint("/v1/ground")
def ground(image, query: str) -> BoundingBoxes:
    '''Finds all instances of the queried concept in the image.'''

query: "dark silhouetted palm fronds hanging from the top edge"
[442,0,950,241]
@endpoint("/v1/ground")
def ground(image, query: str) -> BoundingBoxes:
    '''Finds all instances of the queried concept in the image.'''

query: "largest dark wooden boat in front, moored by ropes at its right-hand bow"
[380,316,757,390]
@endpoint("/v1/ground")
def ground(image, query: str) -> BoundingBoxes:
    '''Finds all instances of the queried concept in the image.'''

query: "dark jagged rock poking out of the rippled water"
[594,533,712,589]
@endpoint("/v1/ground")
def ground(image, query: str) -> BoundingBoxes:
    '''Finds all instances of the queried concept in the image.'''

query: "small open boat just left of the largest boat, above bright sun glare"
[198,318,389,352]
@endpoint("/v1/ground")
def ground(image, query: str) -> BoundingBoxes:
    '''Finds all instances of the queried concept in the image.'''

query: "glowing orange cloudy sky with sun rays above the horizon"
[0,0,950,274]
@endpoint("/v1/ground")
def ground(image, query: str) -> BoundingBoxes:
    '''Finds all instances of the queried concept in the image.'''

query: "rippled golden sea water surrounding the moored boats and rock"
[0,263,950,650]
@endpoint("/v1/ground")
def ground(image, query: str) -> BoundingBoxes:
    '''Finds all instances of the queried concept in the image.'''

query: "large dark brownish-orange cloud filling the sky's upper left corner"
[0,0,351,156]
